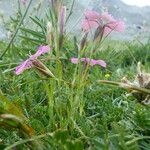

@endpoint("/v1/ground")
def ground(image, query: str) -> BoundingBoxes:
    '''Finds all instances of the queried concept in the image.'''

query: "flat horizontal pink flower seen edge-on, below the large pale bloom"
[71,57,107,68]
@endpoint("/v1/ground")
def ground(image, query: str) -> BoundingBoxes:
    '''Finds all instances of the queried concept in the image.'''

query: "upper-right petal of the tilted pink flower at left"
[30,45,51,59]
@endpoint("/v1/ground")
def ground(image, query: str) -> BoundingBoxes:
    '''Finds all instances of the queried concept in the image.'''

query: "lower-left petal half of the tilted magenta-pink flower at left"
[15,59,33,75]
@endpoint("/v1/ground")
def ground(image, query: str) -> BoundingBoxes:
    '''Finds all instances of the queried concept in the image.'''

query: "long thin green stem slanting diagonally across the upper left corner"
[0,0,33,59]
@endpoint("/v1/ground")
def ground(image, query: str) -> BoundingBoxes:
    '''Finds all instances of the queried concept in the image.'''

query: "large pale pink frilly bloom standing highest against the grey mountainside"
[81,11,125,34]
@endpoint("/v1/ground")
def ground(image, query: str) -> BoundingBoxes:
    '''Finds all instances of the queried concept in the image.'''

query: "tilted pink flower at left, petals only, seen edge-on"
[15,45,50,75]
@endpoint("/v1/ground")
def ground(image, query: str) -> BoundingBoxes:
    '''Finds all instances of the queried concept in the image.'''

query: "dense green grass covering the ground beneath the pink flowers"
[0,39,150,150]
